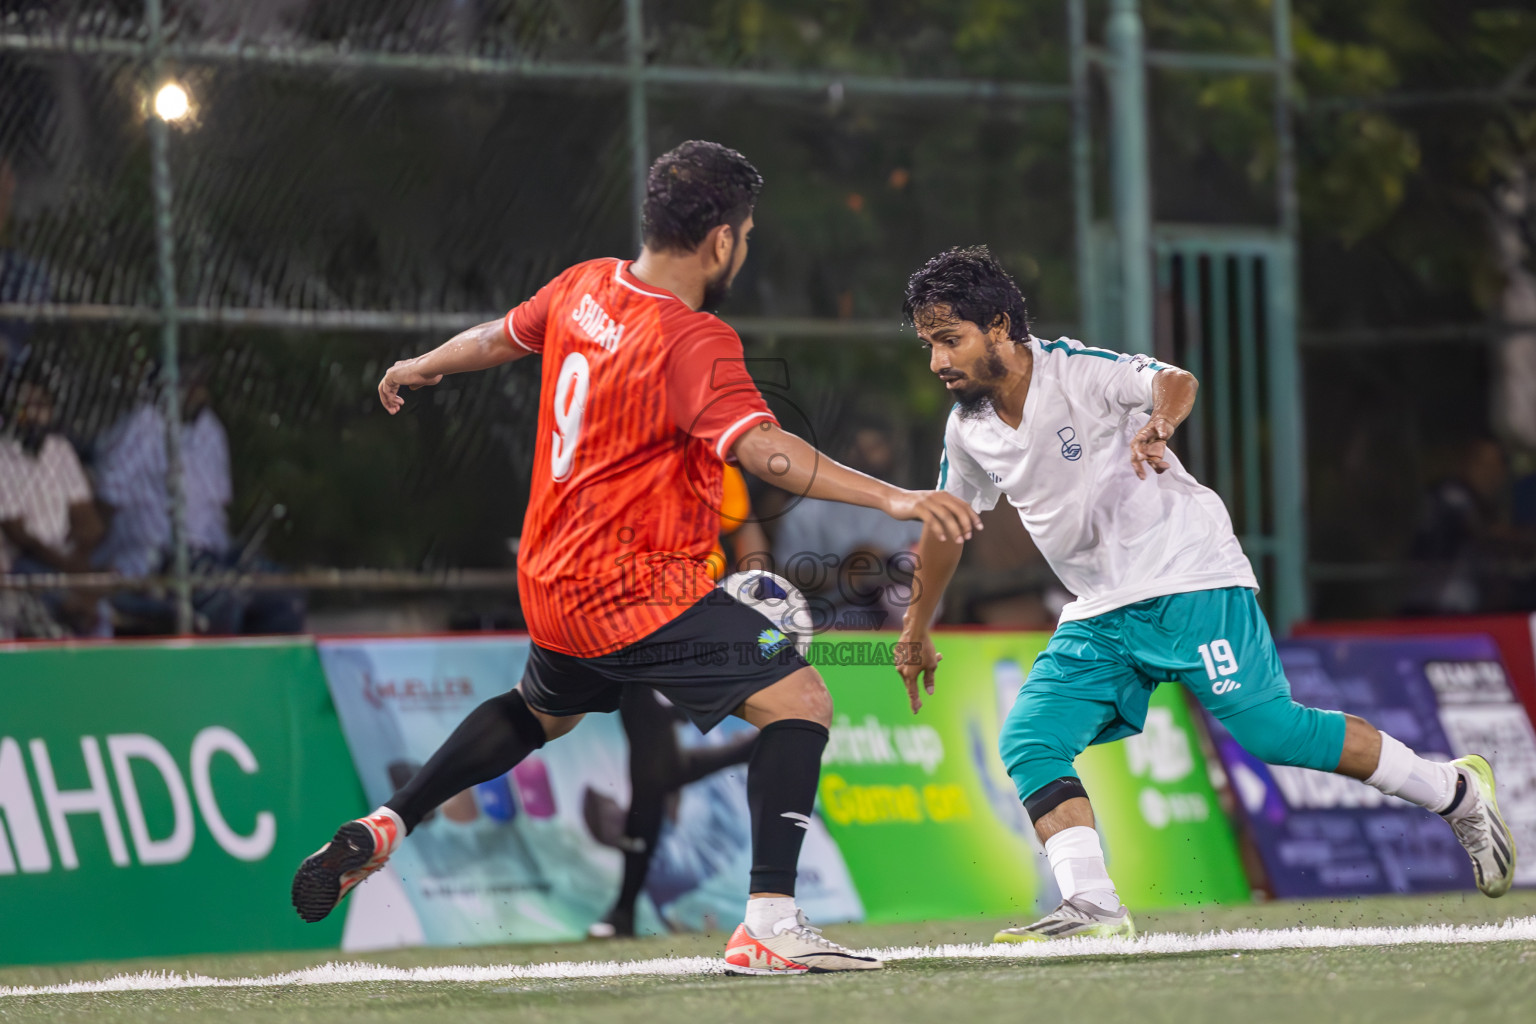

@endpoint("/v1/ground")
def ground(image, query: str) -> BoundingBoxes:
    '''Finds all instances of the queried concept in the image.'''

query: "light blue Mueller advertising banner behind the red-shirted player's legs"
[319,637,863,950]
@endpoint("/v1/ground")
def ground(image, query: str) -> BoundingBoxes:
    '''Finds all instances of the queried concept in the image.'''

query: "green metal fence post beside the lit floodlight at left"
[144,0,192,634]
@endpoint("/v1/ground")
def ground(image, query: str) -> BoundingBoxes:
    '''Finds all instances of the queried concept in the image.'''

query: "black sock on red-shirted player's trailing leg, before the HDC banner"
[384,689,544,834]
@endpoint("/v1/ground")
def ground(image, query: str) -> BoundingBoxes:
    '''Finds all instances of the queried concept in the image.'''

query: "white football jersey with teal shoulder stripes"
[938,338,1258,622]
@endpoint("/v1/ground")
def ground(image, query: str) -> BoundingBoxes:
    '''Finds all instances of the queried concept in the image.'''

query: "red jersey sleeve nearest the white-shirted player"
[667,321,779,462]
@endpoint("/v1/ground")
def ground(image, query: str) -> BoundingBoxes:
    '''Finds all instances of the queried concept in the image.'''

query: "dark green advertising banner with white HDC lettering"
[0,640,364,964]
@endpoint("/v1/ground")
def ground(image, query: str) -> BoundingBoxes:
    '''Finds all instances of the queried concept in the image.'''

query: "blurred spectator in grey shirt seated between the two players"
[773,425,923,629]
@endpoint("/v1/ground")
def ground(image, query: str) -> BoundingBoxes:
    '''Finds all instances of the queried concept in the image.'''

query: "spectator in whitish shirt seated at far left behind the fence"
[0,372,106,636]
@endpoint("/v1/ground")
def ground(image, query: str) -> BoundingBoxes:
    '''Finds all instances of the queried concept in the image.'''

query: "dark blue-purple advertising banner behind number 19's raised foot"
[1207,636,1536,897]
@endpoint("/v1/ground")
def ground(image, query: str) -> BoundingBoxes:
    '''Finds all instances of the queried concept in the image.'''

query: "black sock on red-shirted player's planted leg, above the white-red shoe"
[746,718,828,897]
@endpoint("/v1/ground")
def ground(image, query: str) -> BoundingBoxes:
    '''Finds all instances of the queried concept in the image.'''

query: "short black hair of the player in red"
[641,140,763,252]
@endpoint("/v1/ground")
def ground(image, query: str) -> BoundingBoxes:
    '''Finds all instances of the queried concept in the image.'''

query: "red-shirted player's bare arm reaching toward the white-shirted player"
[731,422,982,543]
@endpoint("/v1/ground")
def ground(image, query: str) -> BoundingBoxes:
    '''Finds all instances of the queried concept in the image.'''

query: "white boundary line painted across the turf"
[0,917,1536,998]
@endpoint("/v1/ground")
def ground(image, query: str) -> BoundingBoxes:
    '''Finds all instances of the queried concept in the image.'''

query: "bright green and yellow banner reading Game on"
[811,633,1250,921]
